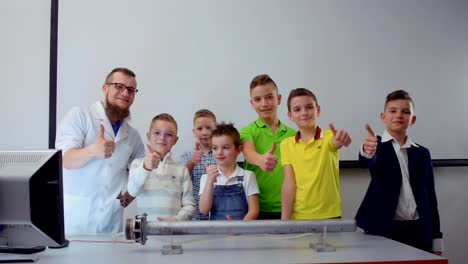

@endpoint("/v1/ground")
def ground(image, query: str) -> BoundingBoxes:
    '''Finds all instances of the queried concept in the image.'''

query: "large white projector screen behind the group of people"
[57,0,468,161]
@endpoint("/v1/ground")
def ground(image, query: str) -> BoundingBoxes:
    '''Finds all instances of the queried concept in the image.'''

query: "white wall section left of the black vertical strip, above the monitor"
[0,0,50,149]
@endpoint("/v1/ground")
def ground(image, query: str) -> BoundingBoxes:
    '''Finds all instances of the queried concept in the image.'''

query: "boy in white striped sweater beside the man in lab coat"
[120,113,195,221]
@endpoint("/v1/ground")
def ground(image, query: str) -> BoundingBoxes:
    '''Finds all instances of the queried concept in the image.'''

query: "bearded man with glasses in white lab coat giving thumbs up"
[55,68,145,234]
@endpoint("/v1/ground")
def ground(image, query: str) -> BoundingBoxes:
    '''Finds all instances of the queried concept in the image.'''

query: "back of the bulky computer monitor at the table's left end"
[0,150,68,250]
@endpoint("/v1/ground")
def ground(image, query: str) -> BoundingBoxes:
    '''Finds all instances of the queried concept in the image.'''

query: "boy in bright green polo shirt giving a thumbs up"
[240,74,296,219]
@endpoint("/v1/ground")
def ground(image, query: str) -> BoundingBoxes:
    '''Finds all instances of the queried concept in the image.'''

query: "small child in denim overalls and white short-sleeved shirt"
[200,123,259,220]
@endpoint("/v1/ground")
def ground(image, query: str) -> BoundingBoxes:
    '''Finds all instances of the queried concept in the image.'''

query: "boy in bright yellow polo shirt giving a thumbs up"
[281,88,351,220]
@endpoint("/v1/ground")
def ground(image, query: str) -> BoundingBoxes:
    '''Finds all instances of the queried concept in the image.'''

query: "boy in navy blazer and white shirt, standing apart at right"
[356,90,443,255]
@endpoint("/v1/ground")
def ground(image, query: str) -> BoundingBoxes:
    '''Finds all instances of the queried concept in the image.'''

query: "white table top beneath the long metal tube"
[0,231,448,264]
